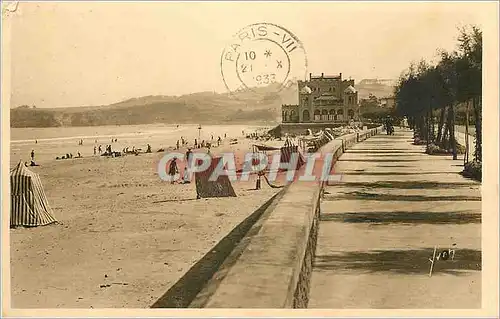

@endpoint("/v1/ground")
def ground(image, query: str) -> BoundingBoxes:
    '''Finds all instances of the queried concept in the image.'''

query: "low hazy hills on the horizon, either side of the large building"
[10,80,393,127]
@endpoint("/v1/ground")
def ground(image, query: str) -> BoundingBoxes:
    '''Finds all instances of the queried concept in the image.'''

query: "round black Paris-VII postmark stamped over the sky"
[221,23,307,93]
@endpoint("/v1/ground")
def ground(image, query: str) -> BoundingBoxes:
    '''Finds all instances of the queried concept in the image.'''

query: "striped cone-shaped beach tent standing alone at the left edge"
[10,162,57,227]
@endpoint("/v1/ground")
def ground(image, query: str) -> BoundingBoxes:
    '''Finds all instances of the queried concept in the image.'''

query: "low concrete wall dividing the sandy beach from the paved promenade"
[191,127,381,308]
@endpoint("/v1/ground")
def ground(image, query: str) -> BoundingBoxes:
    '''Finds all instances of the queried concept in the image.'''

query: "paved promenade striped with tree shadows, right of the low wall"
[309,130,481,309]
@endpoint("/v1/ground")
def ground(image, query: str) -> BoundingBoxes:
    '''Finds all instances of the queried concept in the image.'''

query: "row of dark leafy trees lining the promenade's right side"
[395,26,482,162]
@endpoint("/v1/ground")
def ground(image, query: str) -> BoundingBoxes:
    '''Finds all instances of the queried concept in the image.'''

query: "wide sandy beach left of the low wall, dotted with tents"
[10,125,283,308]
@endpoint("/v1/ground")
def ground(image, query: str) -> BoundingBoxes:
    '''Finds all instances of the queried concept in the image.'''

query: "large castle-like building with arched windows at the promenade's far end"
[281,73,359,123]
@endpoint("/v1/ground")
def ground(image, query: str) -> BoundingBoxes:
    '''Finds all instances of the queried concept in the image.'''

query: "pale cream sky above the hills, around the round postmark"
[9,2,488,107]
